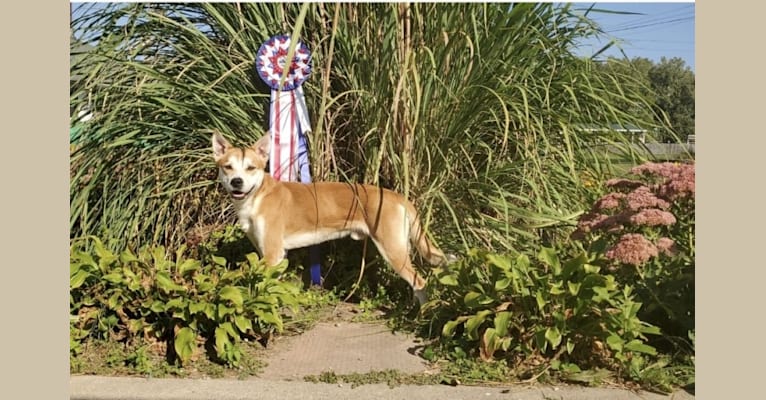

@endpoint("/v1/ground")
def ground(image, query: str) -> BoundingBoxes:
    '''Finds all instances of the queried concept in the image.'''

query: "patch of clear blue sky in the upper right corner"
[574,2,695,71]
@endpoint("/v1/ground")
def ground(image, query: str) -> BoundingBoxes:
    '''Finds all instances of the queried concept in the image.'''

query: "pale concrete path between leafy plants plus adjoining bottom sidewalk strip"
[69,304,694,400]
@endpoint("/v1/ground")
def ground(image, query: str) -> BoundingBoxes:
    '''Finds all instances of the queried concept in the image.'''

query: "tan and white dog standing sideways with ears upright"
[212,132,446,304]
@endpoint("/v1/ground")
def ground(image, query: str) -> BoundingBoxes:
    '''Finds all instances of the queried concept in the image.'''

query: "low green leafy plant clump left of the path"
[70,237,304,366]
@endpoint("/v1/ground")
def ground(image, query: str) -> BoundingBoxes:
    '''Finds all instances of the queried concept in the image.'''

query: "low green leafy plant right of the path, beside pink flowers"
[424,248,659,377]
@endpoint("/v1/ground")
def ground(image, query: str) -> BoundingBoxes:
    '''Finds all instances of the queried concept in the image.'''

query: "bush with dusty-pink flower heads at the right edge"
[572,162,695,352]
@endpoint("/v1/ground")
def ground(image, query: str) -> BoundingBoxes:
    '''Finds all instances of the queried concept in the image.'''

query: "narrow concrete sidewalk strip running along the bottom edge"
[69,376,694,400]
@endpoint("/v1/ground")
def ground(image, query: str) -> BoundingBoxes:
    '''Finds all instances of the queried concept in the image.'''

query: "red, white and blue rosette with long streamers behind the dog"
[255,35,322,285]
